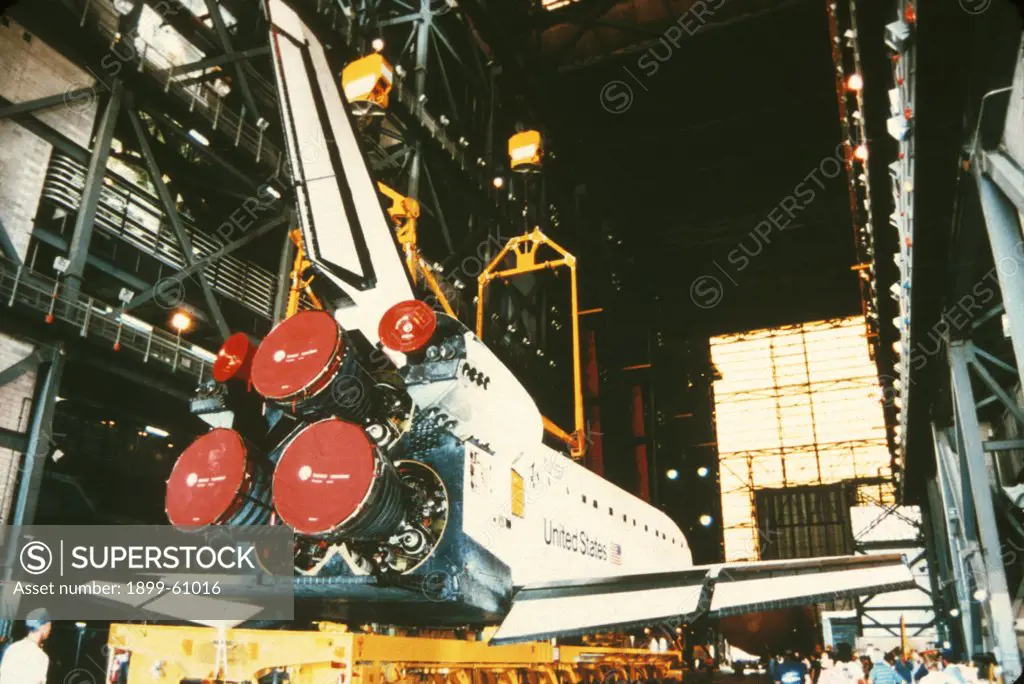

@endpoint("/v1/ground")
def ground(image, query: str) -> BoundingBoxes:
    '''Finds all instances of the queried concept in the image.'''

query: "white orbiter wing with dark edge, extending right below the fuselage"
[490,554,916,645]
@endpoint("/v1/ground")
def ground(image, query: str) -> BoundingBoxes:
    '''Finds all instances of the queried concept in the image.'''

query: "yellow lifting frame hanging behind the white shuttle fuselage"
[476,228,587,459]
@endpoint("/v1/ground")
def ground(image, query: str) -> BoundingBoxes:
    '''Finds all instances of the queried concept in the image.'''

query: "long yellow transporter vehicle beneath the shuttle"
[108,623,682,684]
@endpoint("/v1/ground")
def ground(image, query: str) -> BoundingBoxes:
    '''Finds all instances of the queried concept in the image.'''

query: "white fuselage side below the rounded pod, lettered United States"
[463,444,693,586]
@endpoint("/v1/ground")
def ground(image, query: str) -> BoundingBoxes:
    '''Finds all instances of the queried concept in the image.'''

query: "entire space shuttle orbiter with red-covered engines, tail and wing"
[157,0,915,643]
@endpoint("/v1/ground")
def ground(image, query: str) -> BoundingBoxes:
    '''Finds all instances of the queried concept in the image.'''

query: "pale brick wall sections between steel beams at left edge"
[0,20,97,524]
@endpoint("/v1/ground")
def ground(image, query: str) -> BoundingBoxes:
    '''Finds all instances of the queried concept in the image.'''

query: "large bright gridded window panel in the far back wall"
[711,316,892,560]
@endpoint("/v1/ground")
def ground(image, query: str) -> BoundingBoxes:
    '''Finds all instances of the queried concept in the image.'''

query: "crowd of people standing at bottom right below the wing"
[767,643,998,684]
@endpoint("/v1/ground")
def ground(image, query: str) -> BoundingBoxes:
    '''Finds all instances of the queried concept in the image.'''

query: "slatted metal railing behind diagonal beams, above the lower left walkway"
[42,152,278,319]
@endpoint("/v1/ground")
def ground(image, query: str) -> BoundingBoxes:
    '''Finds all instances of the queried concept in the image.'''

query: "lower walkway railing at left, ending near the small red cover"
[0,257,216,386]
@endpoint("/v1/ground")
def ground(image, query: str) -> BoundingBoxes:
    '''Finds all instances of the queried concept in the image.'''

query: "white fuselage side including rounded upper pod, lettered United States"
[409,327,693,586]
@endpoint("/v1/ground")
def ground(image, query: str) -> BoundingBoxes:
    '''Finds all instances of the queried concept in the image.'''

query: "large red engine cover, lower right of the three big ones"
[273,418,375,535]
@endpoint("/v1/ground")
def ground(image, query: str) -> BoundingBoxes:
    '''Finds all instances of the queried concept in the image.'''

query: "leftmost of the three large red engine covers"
[164,428,248,527]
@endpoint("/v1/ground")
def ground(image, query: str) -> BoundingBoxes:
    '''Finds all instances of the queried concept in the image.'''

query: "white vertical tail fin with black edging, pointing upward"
[266,0,414,343]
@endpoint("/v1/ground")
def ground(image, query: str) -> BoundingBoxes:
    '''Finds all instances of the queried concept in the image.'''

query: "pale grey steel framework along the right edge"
[928,52,1024,681]
